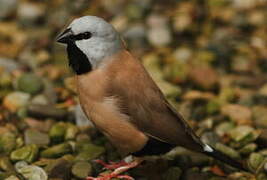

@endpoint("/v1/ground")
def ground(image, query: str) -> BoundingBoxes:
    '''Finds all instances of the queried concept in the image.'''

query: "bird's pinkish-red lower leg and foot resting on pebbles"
[86,158,143,180]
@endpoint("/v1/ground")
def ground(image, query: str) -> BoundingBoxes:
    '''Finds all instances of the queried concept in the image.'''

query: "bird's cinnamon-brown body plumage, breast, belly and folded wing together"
[76,50,203,155]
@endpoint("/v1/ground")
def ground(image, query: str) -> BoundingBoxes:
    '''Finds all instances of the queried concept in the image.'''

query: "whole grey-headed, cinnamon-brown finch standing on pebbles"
[57,16,246,180]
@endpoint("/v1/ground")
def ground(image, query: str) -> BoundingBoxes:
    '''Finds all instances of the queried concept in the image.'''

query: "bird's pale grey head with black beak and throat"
[57,16,122,74]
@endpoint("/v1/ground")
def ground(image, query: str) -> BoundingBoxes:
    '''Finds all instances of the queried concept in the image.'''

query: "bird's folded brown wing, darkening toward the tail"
[109,52,203,151]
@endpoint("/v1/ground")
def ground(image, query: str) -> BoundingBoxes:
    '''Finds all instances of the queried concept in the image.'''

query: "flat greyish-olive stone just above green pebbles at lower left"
[24,129,50,146]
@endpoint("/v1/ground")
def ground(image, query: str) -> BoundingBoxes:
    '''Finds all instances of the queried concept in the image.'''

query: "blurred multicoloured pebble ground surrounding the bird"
[0,0,267,180]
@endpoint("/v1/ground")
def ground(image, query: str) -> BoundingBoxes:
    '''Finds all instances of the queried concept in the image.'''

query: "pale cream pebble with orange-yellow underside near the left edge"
[3,91,30,112]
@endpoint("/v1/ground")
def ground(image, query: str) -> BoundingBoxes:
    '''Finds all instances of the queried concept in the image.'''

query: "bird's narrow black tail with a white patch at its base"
[204,144,249,171]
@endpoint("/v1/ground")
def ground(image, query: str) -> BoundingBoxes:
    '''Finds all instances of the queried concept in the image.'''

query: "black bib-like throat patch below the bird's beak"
[67,42,92,75]
